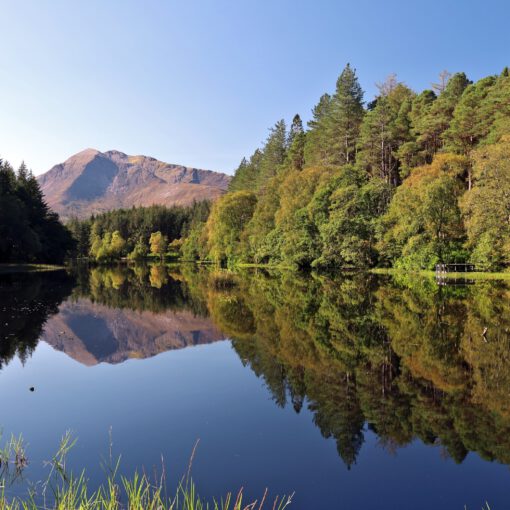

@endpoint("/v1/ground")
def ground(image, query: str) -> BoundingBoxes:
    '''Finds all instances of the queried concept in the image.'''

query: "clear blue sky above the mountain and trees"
[0,0,510,173]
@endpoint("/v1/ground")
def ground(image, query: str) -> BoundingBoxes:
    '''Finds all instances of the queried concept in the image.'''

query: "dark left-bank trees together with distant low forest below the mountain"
[0,154,211,264]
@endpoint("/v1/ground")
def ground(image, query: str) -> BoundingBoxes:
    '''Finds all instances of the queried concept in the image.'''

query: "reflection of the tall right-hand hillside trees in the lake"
[217,275,510,466]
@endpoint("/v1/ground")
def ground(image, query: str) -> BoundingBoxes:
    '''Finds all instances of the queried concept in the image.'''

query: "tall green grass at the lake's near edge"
[0,433,293,510]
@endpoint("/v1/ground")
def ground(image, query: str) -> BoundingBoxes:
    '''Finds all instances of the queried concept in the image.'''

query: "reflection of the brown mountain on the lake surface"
[41,299,225,366]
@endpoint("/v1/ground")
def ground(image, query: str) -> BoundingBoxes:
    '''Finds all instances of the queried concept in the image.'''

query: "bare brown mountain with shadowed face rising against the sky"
[37,149,231,218]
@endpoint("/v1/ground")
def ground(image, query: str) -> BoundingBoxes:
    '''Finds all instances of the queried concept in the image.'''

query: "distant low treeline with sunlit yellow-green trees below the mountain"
[67,200,211,262]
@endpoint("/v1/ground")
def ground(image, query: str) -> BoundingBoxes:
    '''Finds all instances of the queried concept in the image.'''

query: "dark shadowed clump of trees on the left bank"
[0,160,74,263]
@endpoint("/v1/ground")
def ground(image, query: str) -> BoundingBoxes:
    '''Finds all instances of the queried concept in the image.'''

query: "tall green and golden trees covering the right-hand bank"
[183,65,510,269]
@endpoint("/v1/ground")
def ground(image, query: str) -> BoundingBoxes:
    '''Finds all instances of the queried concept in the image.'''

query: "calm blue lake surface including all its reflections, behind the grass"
[0,267,510,510]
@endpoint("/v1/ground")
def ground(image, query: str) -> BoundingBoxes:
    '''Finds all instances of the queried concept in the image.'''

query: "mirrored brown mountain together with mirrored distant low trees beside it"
[42,266,224,365]
